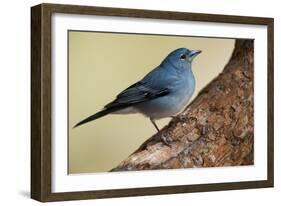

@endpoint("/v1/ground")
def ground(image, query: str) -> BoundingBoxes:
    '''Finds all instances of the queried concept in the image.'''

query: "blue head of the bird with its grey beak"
[162,48,201,68]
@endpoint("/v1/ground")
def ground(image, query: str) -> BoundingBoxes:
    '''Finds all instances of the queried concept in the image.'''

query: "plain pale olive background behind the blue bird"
[68,31,235,174]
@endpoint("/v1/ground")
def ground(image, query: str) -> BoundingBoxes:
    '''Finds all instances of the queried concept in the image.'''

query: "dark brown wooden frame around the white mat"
[31,4,274,202]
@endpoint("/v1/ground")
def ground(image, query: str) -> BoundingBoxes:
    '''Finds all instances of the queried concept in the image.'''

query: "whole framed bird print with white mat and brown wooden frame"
[31,4,274,202]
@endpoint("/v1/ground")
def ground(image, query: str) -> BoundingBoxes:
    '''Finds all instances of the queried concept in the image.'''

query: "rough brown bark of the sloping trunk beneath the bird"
[112,40,254,171]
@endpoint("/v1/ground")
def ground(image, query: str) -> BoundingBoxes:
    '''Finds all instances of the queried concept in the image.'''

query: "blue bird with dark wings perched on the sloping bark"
[74,48,201,145]
